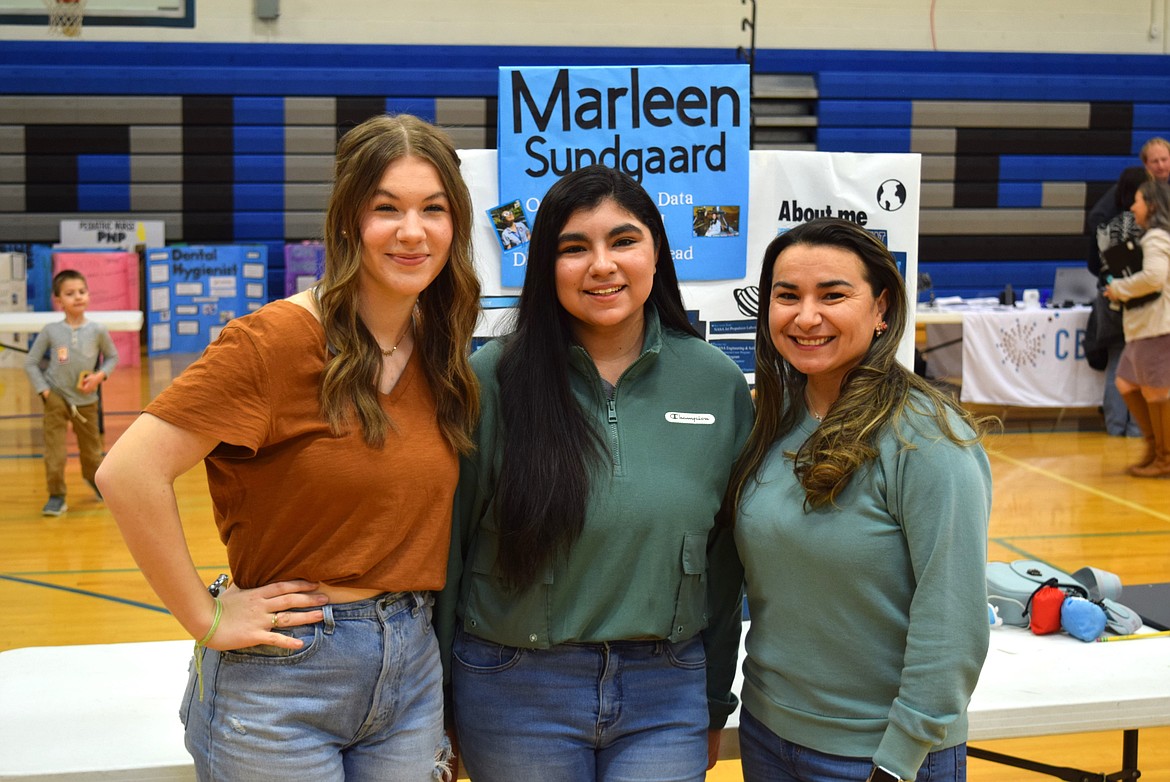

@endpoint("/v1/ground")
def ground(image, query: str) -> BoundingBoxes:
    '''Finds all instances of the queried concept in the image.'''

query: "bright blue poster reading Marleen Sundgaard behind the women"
[498,64,750,287]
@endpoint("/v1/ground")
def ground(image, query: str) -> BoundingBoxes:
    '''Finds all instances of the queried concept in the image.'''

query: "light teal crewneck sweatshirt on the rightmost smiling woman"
[735,402,991,778]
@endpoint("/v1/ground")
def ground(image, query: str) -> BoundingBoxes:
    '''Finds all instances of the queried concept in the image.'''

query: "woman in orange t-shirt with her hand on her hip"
[98,115,479,782]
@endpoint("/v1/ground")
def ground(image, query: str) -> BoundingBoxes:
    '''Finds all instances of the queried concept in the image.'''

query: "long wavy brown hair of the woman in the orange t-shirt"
[318,114,480,453]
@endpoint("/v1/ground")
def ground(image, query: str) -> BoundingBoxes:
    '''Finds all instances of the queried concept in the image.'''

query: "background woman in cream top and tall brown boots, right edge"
[1104,180,1170,478]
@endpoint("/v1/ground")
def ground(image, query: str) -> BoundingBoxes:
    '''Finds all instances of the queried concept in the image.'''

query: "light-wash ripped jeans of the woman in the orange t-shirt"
[180,592,449,782]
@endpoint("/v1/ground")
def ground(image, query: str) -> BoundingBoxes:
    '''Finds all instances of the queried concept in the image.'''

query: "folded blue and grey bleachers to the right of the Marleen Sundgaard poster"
[757,52,1170,297]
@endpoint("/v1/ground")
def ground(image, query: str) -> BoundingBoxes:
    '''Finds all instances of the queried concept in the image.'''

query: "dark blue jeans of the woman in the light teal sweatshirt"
[739,709,966,782]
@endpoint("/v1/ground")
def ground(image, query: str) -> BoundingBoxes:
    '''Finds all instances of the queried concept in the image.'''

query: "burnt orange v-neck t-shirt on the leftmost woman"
[146,301,459,591]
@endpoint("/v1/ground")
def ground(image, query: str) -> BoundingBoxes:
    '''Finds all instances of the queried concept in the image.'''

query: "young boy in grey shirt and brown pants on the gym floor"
[25,269,118,516]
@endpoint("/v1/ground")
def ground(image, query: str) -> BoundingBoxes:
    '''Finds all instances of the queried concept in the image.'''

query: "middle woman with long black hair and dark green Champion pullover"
[440,165,751,782]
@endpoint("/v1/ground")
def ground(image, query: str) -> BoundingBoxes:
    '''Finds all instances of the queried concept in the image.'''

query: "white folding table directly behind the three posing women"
[0,627,1170,782]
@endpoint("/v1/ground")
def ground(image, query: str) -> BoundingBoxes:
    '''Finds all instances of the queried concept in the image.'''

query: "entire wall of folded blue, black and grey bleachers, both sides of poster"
[0,41,1170,295]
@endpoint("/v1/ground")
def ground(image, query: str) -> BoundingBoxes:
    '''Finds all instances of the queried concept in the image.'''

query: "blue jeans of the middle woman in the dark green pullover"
[452,630,709,782]
